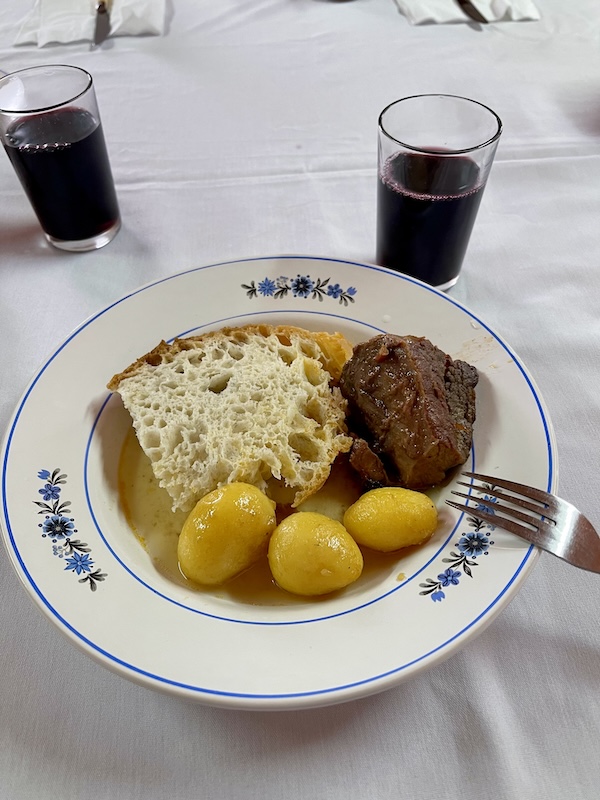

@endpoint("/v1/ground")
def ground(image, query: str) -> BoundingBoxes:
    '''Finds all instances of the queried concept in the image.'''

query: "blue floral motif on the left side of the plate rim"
[33,469,106,592]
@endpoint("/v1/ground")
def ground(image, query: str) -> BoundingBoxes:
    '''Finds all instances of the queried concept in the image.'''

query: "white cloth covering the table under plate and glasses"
[0,0,600,800]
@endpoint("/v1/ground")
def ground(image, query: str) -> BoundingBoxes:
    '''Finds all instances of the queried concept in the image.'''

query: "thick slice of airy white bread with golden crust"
[108,325,352,511]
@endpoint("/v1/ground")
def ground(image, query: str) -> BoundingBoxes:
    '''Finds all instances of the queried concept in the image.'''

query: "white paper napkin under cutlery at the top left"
[14,0,166,47]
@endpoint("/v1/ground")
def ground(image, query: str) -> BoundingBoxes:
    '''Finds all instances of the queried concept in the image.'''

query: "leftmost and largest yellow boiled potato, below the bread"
[177,483,276,586]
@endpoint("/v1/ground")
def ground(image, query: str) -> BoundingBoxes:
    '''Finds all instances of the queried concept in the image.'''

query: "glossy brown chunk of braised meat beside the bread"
[340,334,478,488]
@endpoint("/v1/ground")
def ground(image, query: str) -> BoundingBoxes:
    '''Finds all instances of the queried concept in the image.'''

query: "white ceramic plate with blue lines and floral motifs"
[2,256,556,709]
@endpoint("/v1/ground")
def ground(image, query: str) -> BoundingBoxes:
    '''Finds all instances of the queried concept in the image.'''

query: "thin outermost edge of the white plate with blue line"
[0,254,558,710]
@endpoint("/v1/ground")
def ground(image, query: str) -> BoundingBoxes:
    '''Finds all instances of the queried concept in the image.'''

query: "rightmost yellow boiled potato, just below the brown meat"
[344,486,438,553]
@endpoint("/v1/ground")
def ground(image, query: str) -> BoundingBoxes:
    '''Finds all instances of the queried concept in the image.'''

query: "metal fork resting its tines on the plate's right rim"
[446,472,600,573]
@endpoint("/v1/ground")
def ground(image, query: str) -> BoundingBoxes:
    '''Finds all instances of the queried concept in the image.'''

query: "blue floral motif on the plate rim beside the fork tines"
[419,486,497,602]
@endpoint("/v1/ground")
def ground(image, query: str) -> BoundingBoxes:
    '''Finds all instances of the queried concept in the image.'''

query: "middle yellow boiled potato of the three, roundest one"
[268,511,363,596]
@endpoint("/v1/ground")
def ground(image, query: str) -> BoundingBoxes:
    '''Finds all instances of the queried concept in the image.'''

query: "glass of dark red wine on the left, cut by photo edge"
[0,65,121,252]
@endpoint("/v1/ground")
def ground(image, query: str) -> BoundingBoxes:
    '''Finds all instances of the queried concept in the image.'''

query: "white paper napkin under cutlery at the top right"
[395,0,540,25]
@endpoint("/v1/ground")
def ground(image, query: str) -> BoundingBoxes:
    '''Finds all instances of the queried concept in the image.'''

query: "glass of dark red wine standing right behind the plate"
[376,94,502,291]
